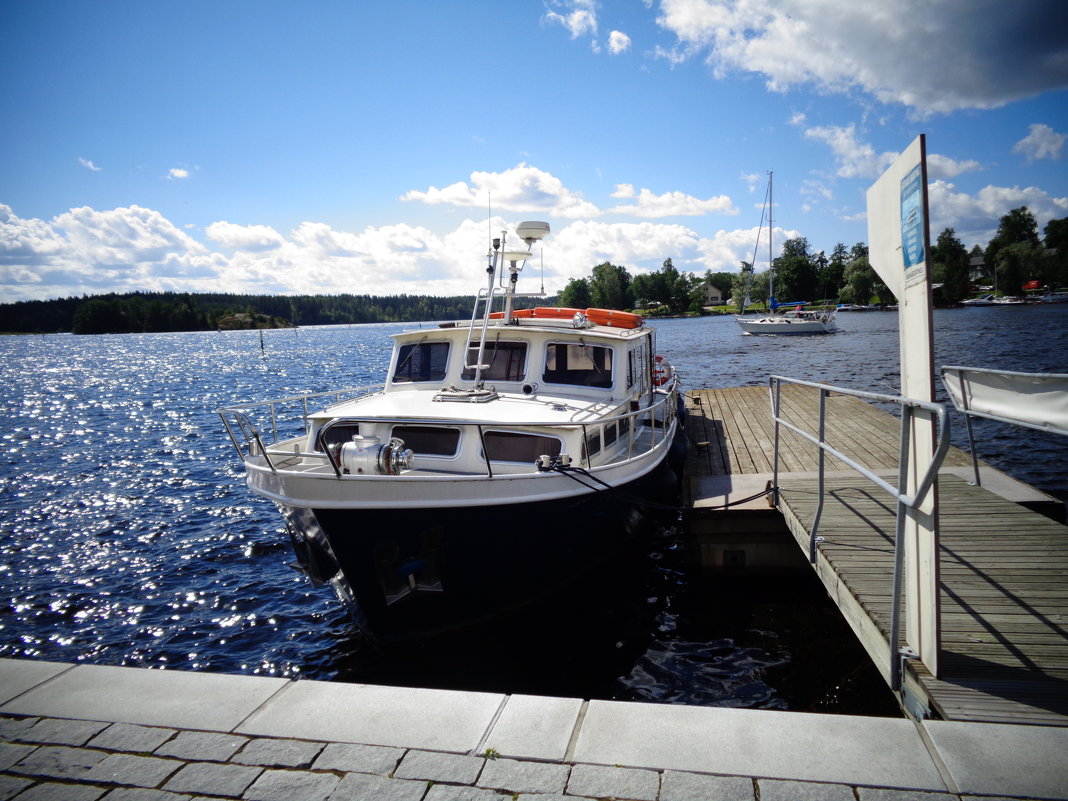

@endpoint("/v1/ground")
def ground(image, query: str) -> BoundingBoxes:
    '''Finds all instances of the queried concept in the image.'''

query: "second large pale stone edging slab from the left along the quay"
[0,663,290,732]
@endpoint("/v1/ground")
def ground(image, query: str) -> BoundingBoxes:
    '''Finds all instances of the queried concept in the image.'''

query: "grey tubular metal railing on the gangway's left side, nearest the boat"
[768,376,949,692]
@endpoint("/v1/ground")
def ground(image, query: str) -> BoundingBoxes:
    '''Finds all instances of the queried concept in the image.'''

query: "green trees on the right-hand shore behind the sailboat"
[560,206,1068,314]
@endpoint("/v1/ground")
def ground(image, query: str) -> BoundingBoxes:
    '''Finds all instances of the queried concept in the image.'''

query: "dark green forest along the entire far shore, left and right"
[0,206,1068,334]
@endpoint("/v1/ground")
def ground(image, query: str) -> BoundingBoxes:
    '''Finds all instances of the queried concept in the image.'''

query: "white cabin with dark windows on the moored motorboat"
[305,317,657,475]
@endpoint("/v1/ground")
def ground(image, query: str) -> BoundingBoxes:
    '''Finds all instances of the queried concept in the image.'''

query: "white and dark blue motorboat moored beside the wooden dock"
[219,222,686,642]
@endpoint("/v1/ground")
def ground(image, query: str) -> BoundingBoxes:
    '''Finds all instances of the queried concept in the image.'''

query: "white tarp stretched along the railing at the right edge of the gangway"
[942,367,1068,435]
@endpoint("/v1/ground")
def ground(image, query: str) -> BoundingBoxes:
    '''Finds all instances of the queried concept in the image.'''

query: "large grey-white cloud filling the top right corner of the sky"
[657,0,1068,112]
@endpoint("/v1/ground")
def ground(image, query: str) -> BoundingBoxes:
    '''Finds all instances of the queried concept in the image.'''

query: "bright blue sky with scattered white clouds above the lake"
[0,0,1068,302]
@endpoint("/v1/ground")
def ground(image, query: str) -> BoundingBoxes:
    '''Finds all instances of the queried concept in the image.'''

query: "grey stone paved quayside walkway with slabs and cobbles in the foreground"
[0,660,1068,801]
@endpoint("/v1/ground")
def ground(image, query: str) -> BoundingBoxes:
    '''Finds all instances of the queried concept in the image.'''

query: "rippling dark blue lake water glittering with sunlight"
[0,305,1068,712]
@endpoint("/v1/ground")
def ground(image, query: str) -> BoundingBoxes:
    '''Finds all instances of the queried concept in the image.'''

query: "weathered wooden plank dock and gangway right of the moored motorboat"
[687,386,1068,726]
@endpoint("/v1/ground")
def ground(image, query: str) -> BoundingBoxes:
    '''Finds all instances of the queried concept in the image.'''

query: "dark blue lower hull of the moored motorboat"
[283,436,685,641]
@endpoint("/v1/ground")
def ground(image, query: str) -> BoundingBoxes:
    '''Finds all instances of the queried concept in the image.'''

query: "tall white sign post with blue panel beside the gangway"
[867,134,941,690]
